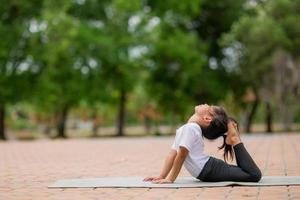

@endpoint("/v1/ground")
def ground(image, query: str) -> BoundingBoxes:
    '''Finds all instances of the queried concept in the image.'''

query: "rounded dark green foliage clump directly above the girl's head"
[146,7,206,119]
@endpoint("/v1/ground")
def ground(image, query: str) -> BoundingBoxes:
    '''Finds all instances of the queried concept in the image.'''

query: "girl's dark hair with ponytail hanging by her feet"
[201,106,237,162]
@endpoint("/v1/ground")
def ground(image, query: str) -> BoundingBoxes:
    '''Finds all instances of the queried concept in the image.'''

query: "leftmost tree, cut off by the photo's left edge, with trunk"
[0,0,42,139]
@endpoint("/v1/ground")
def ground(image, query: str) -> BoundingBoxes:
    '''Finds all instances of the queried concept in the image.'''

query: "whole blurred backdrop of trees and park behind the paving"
[0,0,300,140]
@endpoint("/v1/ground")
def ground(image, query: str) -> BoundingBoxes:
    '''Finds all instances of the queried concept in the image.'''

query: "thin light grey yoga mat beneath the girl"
[48,176,300,188]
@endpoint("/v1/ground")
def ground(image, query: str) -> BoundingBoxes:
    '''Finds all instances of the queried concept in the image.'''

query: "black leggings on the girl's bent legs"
[197,143,261,182]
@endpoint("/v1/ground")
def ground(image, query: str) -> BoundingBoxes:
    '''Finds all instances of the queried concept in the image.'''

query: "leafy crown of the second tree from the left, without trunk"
[30,13,82,109]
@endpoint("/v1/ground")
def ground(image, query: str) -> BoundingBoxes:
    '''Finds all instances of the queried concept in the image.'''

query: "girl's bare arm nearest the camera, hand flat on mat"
[155,147,189,183]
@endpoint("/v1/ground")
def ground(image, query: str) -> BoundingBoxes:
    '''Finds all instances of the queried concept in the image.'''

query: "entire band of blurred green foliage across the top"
[0,0,300,138]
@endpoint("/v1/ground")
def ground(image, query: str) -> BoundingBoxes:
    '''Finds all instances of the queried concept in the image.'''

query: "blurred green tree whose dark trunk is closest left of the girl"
[69,0,152,136]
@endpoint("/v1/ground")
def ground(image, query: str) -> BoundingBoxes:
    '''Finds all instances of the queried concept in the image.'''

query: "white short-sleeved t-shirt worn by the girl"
[172,123,209,178]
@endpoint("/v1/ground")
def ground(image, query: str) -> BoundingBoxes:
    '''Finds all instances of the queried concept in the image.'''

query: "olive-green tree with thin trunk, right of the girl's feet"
[223,0,299,132]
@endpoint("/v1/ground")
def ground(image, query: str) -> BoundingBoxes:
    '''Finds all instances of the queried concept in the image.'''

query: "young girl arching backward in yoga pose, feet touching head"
[144,104,261,183]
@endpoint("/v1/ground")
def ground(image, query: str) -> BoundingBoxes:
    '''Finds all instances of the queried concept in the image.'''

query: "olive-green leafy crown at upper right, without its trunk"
[222,0,300,88]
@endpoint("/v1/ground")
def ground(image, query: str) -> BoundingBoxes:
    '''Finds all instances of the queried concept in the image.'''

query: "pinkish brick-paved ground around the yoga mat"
[0,134,300,200]
